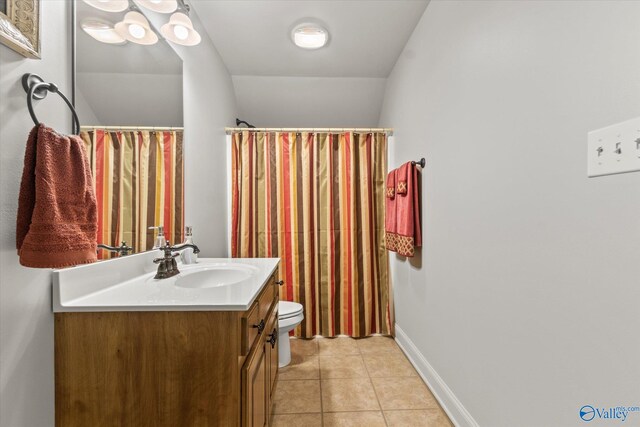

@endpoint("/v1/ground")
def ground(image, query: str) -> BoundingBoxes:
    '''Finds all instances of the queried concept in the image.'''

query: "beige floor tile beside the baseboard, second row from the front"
[370,377,439,411]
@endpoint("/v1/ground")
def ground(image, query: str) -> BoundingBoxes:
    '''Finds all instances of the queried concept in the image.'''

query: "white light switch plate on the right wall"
[587,117,640,177]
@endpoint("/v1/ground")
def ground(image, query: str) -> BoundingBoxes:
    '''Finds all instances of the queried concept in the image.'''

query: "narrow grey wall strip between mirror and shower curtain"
[166,11,237,257]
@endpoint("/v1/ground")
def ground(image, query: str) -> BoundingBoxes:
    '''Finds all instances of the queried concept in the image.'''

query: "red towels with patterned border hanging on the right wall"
[385,162,422,257]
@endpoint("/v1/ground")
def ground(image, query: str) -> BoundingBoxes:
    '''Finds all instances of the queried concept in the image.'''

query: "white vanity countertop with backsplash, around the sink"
[53,251,280,312]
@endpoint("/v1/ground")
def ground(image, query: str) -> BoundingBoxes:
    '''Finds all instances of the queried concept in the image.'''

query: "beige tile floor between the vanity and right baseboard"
[271,336,452,427]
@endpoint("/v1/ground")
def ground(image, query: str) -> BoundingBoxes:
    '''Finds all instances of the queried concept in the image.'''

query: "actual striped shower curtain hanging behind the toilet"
[231,131,392,338]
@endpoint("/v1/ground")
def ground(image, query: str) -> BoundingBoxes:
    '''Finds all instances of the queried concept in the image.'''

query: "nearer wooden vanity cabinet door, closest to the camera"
[242,345,270,427]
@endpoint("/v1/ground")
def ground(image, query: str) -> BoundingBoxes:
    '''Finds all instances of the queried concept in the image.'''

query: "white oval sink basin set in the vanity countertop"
[175,264,257,289]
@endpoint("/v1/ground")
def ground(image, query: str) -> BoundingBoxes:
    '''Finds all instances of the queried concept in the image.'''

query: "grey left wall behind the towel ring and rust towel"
[0,1,71,427]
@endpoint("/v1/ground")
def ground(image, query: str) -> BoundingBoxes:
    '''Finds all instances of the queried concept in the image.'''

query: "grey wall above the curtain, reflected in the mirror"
[76,72,183,126]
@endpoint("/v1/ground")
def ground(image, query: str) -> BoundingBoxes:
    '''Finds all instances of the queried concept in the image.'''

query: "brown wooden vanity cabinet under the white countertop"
[55,275,278,427]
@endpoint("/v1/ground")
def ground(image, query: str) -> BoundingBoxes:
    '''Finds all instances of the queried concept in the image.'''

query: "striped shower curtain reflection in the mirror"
[80,128,184,258]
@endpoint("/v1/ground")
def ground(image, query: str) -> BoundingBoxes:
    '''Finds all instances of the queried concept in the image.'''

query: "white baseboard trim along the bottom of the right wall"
[395,323,479,427]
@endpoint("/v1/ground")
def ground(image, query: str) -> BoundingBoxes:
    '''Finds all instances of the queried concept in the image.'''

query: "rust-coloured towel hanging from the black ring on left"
[16,124,98,268]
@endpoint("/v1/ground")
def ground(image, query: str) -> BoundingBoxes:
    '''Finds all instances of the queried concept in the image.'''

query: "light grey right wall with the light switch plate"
[380,1,640,427]
